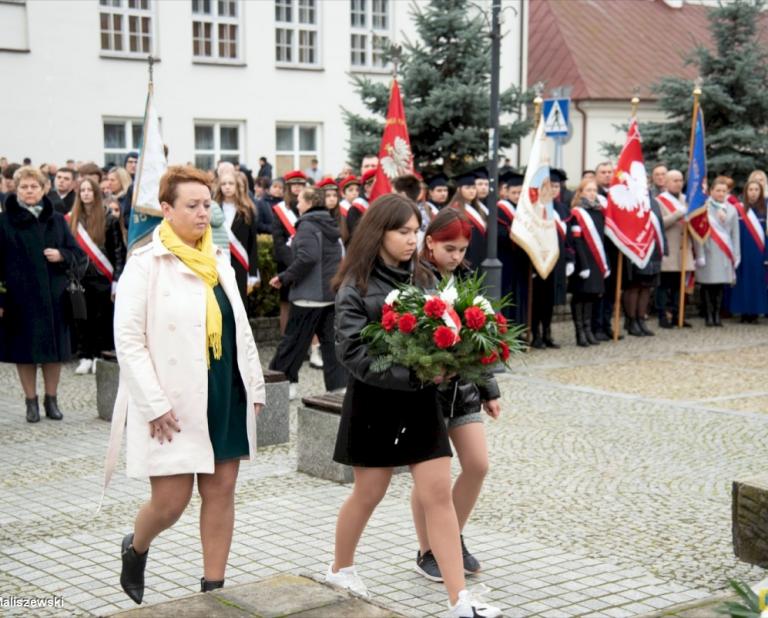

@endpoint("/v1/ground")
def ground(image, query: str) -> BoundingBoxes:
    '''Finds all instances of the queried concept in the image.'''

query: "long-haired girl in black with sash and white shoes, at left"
[67,177,126,375]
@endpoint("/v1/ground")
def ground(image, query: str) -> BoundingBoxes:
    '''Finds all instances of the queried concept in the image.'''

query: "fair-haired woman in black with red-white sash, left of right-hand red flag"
[568,179,611,347]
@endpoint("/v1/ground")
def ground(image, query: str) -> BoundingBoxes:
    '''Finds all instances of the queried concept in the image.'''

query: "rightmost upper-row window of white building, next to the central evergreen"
[349,0,392,69]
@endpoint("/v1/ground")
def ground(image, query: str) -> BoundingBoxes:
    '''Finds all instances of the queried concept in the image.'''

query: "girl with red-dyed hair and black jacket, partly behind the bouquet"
[411,208,501,581]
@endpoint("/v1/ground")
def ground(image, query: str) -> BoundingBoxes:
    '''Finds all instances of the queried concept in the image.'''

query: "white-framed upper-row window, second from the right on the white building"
[274,0,320,66]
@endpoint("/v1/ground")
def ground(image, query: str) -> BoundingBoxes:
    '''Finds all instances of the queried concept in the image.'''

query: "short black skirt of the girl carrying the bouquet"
[333,378,451,468]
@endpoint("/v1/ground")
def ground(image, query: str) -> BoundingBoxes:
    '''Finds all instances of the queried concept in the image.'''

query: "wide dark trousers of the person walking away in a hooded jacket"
[269,303,347,391]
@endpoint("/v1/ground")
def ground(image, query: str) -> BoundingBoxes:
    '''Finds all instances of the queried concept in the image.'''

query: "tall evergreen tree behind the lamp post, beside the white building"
[344,0,532,174]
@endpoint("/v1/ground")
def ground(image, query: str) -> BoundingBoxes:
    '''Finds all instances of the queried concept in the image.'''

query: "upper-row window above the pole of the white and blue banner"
[99,0,152,58]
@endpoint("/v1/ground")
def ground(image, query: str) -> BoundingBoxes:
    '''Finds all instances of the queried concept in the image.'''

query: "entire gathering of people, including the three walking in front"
[0,153,768,618]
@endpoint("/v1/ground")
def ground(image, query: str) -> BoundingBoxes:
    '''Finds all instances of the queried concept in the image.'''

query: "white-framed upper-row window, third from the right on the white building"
[192,0,240,62]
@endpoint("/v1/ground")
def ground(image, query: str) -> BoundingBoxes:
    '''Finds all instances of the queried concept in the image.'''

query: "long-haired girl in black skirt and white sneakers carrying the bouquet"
[326,194,500,618]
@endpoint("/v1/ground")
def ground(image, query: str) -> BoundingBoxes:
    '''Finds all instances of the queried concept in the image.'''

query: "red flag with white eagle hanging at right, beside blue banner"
[605,118,656,268]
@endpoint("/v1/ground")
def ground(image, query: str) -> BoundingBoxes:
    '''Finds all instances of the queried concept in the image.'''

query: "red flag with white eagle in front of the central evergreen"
[369,79,413,203]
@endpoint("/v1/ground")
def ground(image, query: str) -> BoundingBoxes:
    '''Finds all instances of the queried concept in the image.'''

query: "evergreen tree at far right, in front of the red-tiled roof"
[640,0,768,186]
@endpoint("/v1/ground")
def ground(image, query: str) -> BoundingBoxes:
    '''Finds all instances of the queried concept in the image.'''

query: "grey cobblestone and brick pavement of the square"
[0,320,768,618]
